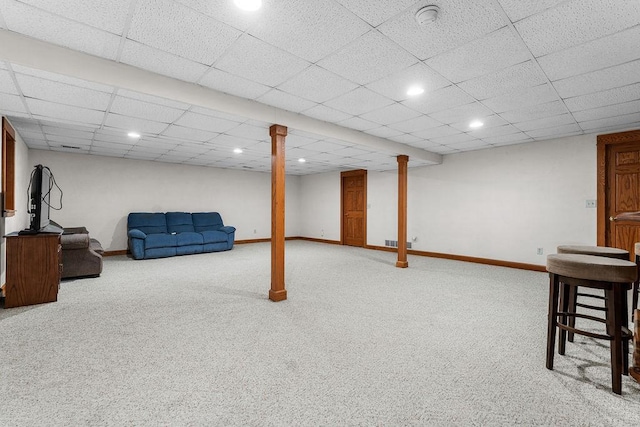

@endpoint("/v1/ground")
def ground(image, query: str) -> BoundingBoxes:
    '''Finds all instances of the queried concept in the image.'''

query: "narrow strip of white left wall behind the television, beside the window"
[0,123,31,283]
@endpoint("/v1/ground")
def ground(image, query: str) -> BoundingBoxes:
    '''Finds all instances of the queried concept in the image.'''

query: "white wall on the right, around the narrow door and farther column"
[301,135,596,265]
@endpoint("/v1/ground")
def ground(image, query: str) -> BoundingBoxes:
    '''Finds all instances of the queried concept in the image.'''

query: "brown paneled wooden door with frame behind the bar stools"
[598,131,640,259]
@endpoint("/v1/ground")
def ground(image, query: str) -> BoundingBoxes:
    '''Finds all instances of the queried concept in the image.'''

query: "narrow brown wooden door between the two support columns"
[341,170,367,247]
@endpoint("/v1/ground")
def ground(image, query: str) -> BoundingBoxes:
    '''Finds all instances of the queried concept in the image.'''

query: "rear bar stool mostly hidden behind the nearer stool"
[557,245,629,344]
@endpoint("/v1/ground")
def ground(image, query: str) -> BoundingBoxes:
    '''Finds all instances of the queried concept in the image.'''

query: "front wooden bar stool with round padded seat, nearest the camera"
[546,254,638,394]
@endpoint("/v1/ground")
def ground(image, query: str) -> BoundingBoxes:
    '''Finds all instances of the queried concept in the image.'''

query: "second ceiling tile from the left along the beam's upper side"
[120,40,208,82]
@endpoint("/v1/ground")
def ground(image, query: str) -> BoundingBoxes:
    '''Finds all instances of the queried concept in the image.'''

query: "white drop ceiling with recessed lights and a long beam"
[0,0,640,175]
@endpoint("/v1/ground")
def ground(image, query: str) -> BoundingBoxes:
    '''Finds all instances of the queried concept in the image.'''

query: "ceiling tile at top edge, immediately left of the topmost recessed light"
[127,0,242,65]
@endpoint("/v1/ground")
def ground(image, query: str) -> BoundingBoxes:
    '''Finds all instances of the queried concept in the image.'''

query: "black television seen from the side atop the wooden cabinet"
[29,165,62,233]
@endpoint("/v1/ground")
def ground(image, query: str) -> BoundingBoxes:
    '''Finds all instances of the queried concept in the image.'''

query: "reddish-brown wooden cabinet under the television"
[4,233,62,308]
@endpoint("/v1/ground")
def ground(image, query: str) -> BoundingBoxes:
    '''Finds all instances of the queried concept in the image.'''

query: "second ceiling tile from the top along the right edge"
[538,25,640,81]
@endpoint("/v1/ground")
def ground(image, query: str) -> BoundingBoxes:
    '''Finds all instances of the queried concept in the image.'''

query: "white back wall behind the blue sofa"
[25,150,300,251]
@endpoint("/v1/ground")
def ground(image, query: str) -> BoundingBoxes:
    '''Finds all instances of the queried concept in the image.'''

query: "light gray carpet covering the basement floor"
[0,241,640,426]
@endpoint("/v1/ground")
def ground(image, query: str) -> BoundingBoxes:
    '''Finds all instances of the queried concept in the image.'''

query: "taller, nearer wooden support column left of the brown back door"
[269,125,287,301]
